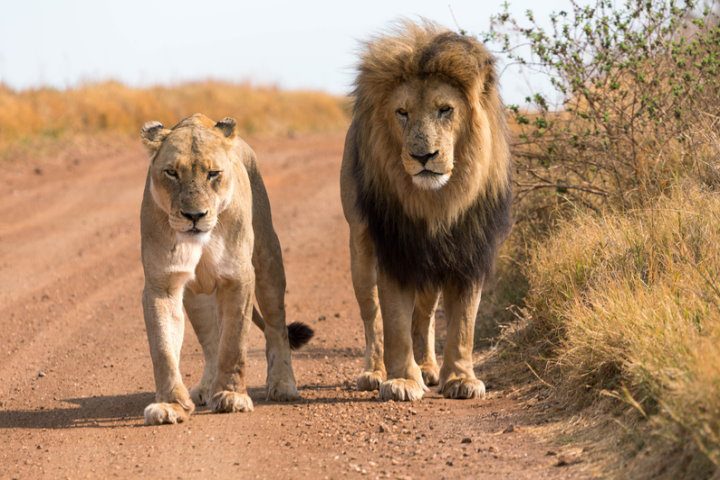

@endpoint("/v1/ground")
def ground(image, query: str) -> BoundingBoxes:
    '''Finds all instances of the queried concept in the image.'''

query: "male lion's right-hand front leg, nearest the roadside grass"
[440,282,485,398]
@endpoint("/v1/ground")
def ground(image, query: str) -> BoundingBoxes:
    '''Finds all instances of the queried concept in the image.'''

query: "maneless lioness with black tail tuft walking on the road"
[140,114,312,425]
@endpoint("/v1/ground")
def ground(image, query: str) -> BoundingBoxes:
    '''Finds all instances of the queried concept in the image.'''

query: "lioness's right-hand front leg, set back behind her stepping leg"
[210,272,255,413]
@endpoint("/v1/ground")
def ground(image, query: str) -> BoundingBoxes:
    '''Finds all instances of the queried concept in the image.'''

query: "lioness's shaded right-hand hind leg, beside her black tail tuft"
[253,227,300,402]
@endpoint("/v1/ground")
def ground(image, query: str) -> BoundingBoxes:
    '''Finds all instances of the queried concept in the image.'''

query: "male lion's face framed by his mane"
[389,79,468,190]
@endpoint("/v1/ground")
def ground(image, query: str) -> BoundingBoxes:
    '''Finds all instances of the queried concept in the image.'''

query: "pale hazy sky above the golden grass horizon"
[0,0,569,103]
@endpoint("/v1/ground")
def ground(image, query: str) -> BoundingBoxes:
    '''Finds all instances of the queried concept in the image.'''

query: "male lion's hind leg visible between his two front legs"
[412,290,440,386]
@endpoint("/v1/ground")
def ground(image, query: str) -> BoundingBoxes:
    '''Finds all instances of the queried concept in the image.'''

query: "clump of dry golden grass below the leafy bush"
[525,182,720,475]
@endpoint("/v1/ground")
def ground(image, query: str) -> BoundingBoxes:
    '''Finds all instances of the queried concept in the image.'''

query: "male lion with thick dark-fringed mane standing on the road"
[340,23,511,400]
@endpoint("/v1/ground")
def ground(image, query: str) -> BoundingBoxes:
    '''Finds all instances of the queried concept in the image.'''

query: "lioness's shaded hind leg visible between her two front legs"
[183,288,220,405]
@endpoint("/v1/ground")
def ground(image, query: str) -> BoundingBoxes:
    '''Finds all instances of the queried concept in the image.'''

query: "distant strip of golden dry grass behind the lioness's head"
[0,81,348,148]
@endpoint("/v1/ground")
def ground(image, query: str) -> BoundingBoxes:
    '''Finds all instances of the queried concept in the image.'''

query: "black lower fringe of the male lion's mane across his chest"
[353,155,512,289]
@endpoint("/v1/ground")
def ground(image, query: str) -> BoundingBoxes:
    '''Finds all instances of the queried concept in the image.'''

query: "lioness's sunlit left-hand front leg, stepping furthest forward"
[143,280,195,425]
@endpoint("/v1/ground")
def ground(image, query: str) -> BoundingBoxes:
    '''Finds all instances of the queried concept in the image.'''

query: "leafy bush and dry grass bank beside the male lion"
[485,0,720,478]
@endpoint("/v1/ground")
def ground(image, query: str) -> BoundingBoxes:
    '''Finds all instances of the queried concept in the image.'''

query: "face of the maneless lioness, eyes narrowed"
[150,126,232,241]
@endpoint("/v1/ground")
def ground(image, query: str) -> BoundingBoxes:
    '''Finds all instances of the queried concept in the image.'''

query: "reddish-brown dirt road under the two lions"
[0,136,586,478]
